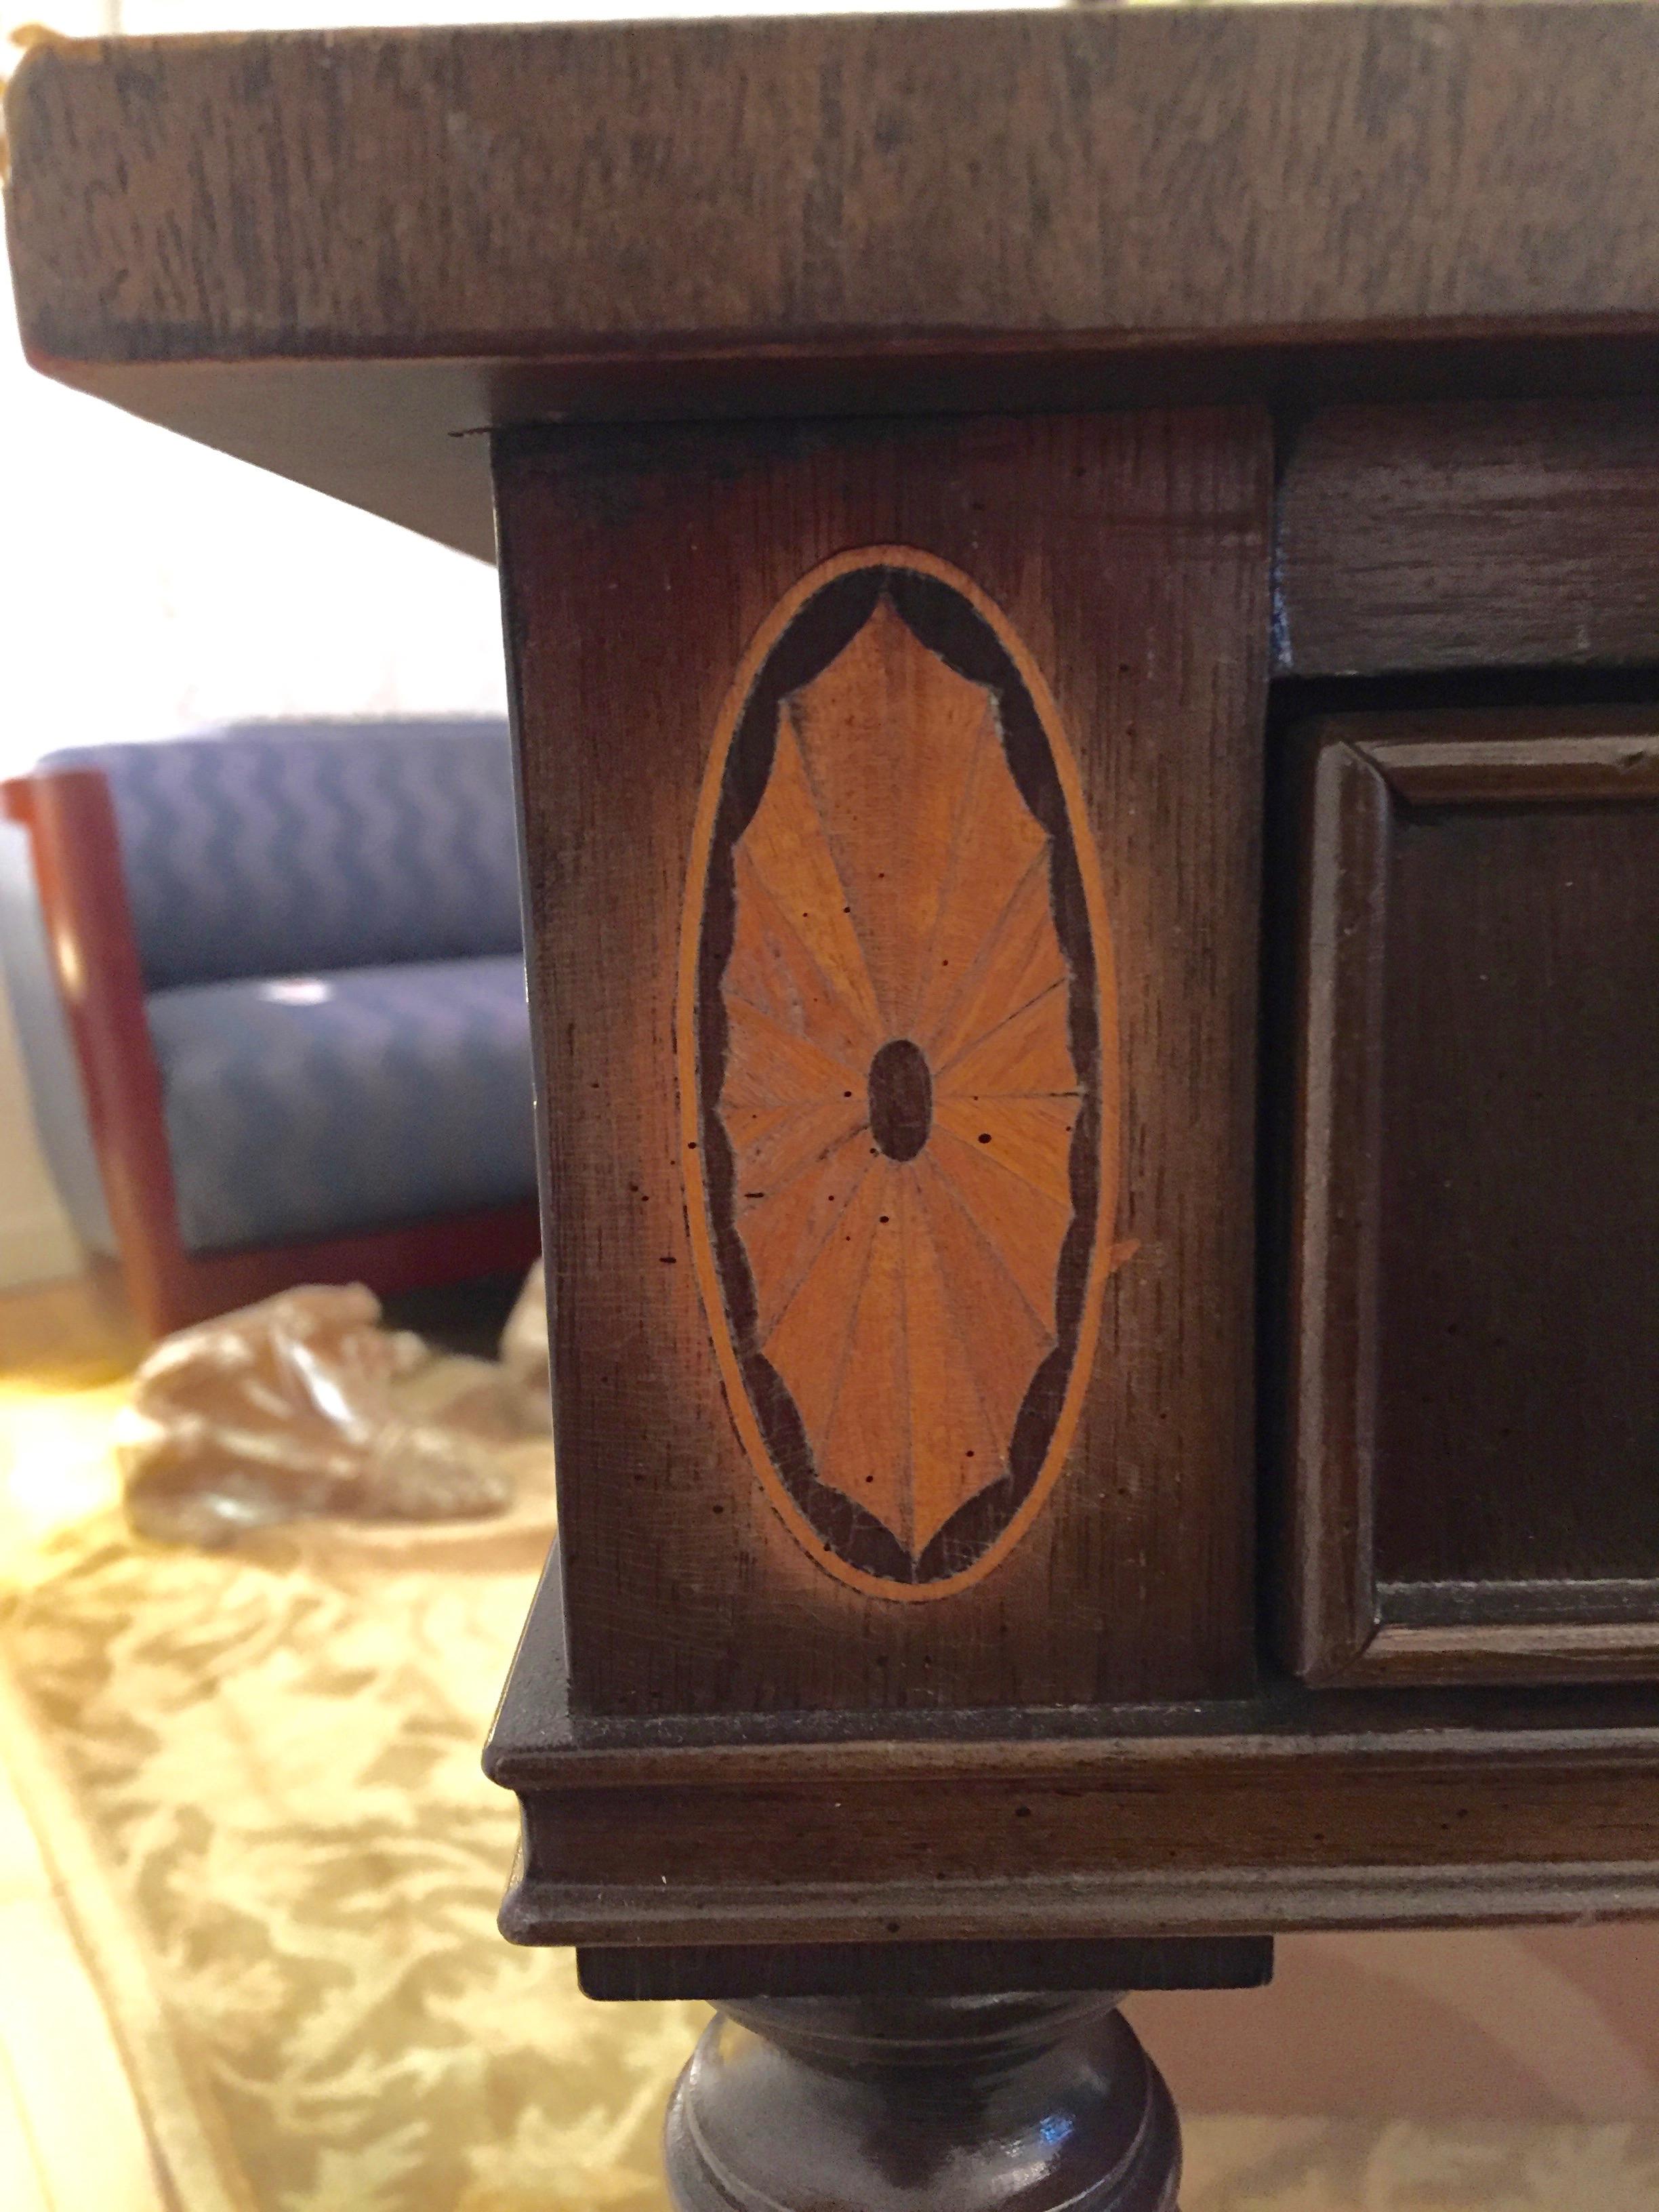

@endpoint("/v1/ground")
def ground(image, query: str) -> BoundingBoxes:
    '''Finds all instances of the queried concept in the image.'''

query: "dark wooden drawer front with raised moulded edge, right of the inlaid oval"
[1288,708,1659,1681]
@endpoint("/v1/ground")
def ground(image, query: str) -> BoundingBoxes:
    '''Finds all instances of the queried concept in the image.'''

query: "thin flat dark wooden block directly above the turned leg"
[575,1936,1274,2002]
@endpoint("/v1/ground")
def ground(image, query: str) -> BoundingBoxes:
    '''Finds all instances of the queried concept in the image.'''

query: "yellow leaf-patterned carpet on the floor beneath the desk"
[0,1385,1659,2212]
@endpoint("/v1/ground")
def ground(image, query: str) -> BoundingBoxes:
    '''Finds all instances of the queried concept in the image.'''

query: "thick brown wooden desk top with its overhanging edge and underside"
[7,0,1659,555]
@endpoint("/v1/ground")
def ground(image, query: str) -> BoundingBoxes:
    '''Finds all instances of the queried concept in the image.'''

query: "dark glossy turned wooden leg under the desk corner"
[668,1995,1181,2212]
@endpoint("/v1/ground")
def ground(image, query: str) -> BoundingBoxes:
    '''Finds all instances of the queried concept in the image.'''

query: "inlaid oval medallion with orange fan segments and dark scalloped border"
[679,546,1117,1599]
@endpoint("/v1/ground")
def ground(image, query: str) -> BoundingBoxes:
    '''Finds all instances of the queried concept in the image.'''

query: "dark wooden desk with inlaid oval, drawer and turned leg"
[9,0,1659,2212]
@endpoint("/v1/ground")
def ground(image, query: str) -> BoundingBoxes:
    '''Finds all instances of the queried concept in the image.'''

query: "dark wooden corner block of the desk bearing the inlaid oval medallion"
[497,413,1267,1712]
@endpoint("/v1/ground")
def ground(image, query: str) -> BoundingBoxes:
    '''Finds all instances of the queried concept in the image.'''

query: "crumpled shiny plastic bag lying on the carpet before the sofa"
[112,1283,513,1544]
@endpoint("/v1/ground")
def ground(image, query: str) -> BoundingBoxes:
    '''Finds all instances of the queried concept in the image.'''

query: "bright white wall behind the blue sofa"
[0,0,1057,1285]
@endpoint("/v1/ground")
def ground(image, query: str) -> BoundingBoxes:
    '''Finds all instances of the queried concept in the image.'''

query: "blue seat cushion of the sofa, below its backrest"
[148,956,535,1252]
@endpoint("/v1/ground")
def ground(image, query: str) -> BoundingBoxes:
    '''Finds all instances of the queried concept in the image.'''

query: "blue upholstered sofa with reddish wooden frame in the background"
[7,721,535,1330]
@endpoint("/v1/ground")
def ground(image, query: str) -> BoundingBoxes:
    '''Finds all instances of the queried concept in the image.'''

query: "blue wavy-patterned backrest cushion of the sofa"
[37,721,522,991]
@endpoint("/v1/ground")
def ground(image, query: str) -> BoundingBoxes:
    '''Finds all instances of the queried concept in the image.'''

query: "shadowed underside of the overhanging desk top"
[22,345,1659,573]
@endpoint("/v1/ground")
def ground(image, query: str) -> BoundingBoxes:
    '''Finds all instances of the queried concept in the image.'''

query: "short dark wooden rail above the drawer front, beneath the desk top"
[1274,387,1659,677]
